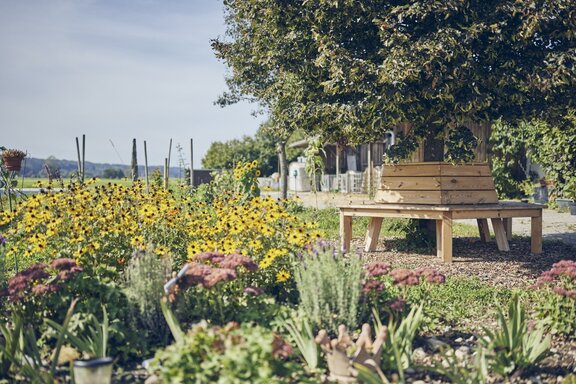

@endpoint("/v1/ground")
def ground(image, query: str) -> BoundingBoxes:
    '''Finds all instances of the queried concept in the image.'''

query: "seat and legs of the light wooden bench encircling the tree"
[338,202,544,263]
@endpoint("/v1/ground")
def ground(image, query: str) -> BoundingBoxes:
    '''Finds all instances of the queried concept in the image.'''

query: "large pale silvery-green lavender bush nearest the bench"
[294,243,364,332]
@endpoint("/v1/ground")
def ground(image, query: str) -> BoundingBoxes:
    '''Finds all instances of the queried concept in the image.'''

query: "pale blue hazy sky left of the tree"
[0,0,263,168]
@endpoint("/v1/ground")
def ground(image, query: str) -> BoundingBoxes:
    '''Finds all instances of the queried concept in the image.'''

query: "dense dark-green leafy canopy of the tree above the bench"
[213,0,576,160]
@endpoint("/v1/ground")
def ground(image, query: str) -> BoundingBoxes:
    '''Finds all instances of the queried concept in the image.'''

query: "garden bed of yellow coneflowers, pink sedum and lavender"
[0,163,576,383]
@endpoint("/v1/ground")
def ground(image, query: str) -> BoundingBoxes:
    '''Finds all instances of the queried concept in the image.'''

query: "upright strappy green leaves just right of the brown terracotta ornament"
[372,305,423,382]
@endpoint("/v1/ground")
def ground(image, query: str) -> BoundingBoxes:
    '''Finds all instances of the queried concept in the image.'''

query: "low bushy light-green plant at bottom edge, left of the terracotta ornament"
[152,323,313,384]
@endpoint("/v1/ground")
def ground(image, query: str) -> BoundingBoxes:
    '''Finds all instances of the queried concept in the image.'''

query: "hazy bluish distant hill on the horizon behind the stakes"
[15,157,191,178]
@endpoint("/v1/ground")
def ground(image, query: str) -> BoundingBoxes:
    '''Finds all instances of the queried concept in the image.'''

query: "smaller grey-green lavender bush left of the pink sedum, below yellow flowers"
[123,247,172,345]
